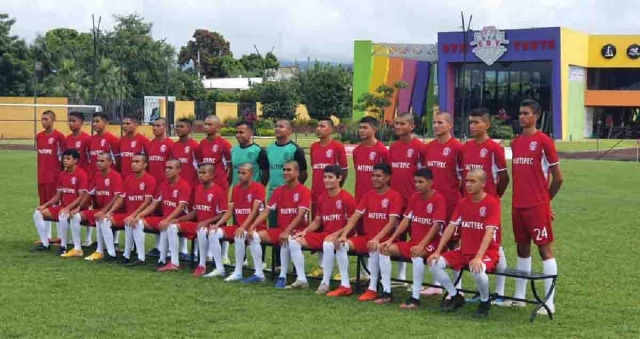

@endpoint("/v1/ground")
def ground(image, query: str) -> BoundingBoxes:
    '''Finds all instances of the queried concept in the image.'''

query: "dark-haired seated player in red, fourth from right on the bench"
[287,165,356,294]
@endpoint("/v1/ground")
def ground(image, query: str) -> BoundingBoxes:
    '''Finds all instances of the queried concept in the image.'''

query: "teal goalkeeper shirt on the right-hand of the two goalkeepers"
[267,141,307,197]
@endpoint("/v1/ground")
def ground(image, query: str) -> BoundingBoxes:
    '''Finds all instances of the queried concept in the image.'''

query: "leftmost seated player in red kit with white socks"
[33,149,89,258]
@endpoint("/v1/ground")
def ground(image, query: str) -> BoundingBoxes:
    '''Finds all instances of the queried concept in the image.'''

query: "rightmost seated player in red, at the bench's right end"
[427,169,500,317]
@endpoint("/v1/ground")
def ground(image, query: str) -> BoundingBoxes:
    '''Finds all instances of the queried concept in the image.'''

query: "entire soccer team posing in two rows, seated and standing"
[33,100,562,316]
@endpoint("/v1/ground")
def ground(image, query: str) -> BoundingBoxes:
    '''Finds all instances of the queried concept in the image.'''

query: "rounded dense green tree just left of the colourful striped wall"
[296,61,352,119]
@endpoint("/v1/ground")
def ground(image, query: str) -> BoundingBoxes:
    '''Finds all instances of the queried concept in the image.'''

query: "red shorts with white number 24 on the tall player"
[511,204,553,246]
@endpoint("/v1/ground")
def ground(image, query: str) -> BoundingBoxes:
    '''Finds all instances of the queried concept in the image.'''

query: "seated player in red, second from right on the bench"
[375,168,447,309]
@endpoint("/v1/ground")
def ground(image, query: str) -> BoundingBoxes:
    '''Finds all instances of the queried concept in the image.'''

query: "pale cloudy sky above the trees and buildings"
[5,0,640,63]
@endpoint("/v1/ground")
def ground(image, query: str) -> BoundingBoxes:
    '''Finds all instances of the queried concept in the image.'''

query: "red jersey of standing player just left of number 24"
[462,139,507,198]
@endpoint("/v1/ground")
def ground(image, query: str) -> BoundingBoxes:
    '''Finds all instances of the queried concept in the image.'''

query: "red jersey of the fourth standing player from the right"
[389,138,425,205]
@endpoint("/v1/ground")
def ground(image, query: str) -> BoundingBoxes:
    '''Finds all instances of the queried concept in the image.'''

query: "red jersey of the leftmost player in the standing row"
[36,129,66,184]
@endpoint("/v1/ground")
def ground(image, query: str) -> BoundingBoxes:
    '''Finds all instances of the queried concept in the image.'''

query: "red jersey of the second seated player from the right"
[404,192,447,241]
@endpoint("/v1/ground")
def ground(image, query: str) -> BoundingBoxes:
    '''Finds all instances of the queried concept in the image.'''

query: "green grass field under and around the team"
[0,151,640,338]
